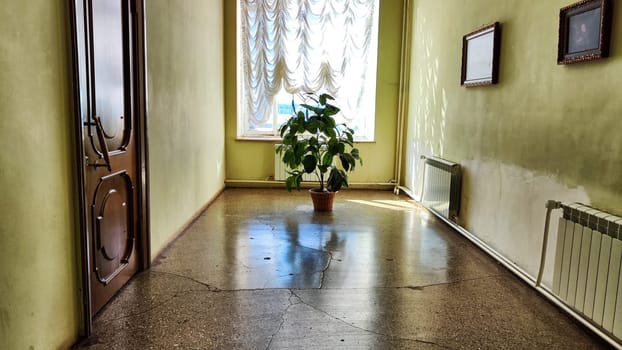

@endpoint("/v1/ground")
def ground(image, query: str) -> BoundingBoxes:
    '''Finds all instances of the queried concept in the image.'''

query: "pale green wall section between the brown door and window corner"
[146,0,225,258]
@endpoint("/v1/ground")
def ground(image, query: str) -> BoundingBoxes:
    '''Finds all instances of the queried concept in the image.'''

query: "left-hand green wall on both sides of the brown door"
[0,0,225,349]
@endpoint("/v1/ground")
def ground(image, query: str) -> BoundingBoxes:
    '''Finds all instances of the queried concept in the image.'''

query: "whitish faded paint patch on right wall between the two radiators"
[460,160,590,276]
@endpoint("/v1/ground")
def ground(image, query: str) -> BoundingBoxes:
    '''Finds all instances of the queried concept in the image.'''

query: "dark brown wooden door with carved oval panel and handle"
[75,0,143,317]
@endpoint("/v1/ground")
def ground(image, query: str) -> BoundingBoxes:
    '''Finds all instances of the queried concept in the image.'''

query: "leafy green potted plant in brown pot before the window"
[276,93,363,211]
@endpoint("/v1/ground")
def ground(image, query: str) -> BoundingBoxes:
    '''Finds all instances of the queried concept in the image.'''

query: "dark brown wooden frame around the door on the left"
[69,0,151,337]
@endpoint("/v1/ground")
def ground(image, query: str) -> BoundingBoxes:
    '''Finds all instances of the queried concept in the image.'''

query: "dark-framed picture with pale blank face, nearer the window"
[460,22,501,87]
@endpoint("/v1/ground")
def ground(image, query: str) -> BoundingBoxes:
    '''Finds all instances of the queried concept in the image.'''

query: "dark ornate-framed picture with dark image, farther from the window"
[557,0,611,64]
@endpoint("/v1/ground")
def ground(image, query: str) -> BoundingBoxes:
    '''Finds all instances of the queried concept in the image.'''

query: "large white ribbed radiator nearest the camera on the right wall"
[553,203,622,341]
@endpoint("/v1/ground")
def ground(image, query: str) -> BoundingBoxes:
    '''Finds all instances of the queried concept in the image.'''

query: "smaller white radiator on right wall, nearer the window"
[421,157,462,222]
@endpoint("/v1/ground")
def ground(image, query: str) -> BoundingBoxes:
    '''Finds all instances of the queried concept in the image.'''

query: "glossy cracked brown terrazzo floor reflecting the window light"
[81,189,606,349]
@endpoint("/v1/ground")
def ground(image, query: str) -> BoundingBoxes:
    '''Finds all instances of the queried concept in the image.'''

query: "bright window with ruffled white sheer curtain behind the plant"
[237,0,378,141]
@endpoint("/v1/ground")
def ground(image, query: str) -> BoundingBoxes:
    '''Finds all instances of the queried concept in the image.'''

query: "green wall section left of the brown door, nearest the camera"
[0,0,80,350]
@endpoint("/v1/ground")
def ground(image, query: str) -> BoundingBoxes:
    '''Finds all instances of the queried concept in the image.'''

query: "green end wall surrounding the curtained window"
[225,0,403,183]
